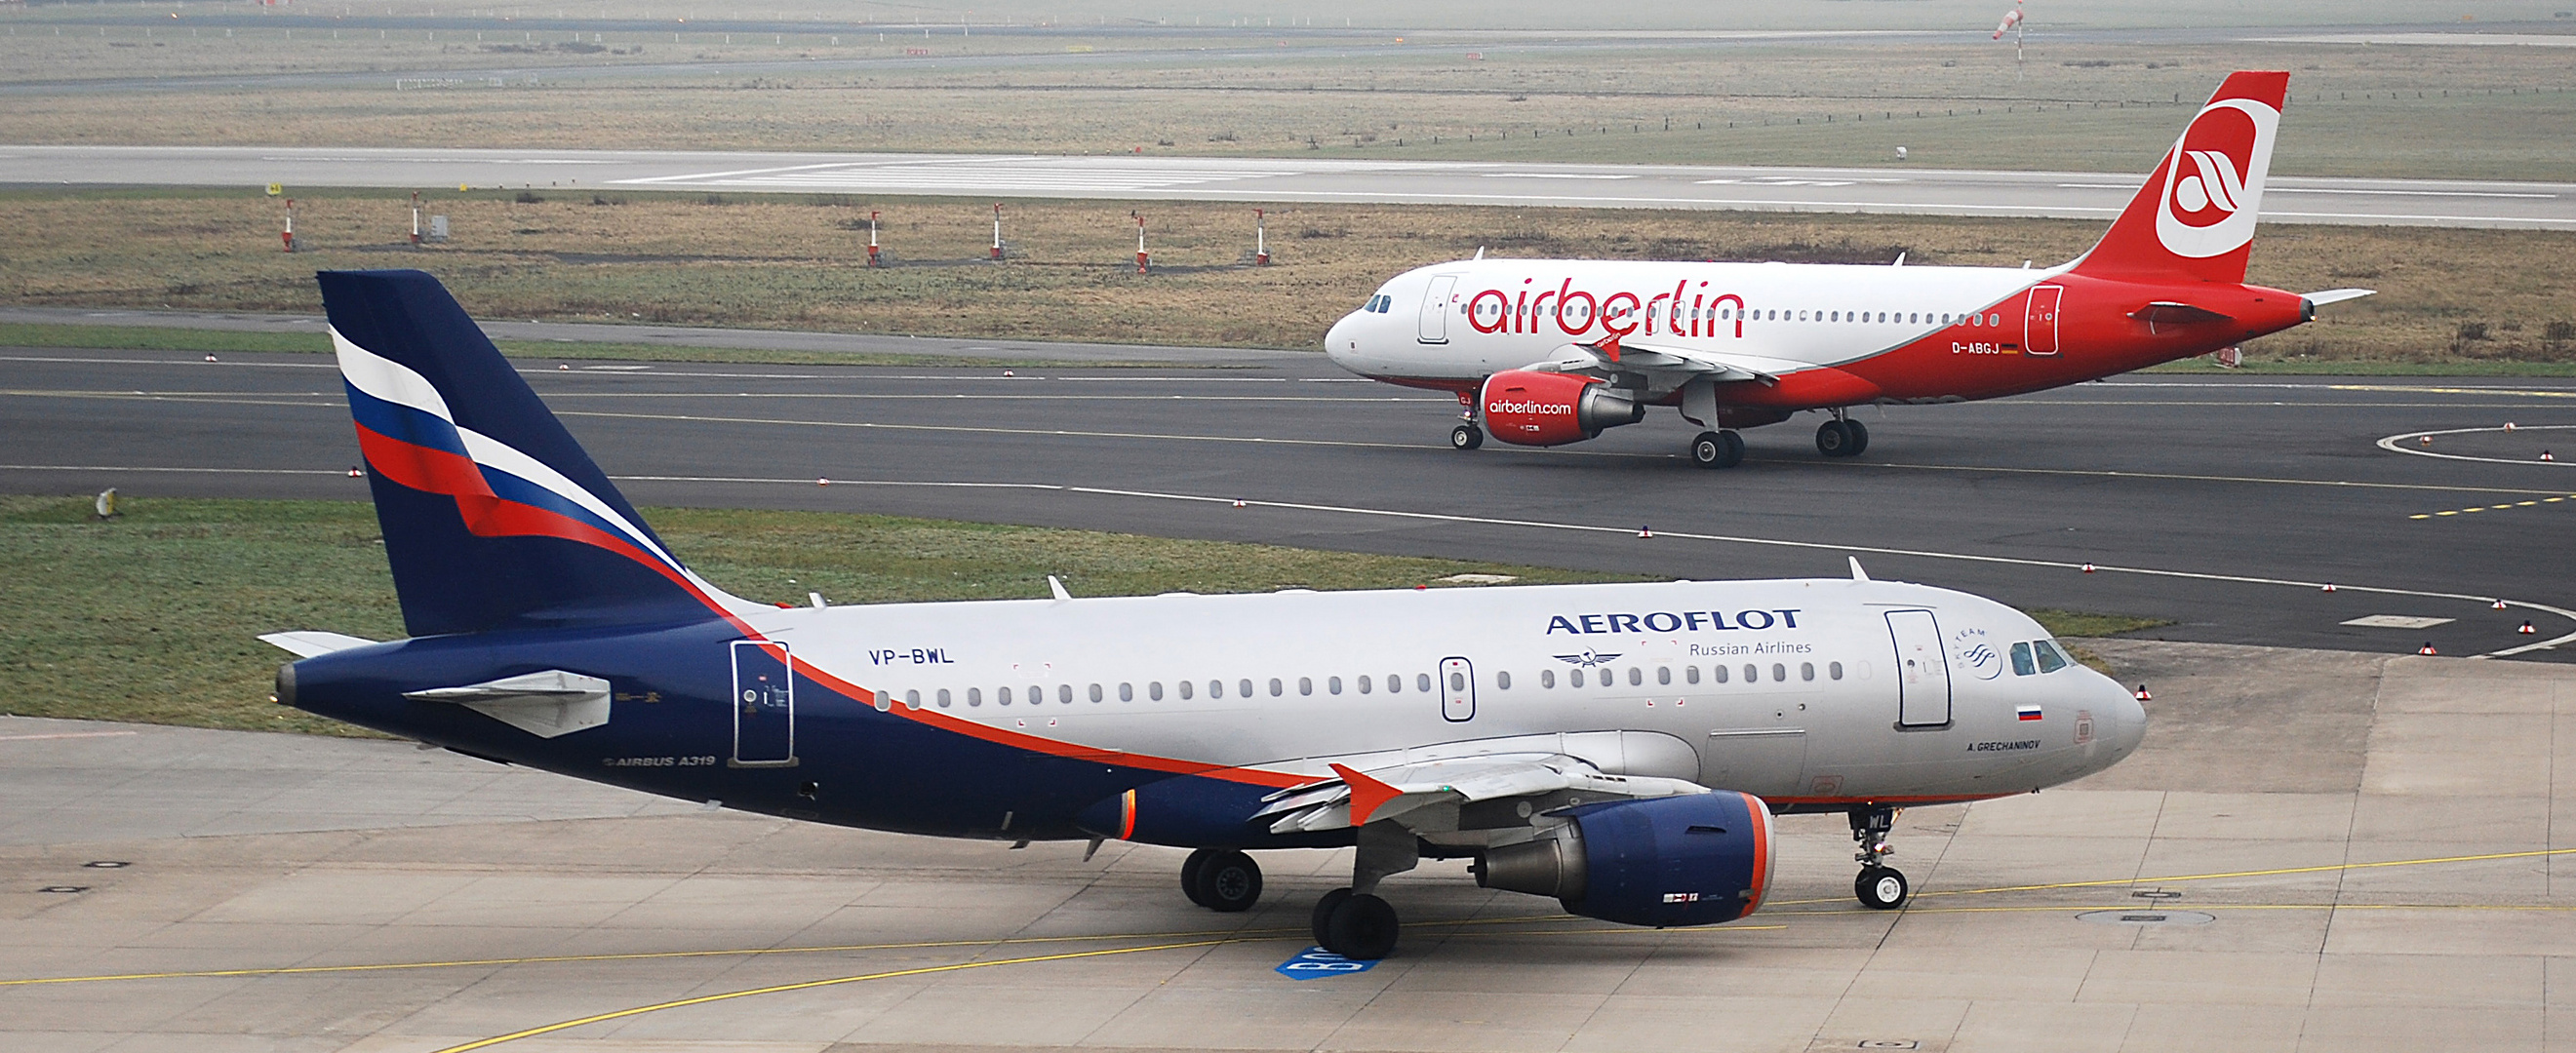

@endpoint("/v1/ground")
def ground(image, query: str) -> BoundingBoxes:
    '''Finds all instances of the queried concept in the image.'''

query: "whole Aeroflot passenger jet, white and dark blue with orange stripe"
[262,270,2146,957]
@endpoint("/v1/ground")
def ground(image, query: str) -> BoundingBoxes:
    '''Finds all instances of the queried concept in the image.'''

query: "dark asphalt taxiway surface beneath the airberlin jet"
[0,339,2576,659]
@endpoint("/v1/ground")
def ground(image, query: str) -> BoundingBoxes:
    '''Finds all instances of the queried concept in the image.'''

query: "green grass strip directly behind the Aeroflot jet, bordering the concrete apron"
[0,497,2161,734]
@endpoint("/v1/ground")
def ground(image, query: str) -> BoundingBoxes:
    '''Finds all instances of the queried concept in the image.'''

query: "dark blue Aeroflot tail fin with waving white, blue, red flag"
[314,270,742,636]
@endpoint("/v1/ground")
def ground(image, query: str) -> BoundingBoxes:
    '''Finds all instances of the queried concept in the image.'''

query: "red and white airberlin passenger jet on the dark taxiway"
[1324,72,2370,469]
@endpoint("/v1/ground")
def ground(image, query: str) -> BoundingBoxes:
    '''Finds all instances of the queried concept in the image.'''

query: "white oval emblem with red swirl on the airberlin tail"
[2157,98,2279,260]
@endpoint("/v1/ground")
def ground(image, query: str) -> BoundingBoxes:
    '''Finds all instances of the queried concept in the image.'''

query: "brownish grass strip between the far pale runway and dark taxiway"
[0,188,2576,373]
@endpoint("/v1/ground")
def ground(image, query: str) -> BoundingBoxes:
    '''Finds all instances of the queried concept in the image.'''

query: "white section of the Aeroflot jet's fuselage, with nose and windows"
[747,579,2146,806]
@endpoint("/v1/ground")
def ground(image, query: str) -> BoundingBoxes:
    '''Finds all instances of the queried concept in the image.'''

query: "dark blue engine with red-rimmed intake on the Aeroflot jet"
[1476,791,1772,929]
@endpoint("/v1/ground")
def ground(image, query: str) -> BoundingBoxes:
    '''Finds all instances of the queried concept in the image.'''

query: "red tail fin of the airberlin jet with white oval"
[2074,72,2290,283]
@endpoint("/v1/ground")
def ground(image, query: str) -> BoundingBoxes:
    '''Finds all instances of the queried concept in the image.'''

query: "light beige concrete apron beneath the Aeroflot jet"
[0,642,2576,1053]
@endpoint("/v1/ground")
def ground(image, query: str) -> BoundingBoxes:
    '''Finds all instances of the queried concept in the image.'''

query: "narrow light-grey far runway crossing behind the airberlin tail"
[0,147,2576,229]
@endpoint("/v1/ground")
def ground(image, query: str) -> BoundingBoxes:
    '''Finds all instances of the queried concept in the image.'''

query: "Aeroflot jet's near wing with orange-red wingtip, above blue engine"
[1252,755,1708,835]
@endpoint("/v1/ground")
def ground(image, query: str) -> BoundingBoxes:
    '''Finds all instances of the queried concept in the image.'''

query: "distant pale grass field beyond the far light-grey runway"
[0,14,2576,180]
